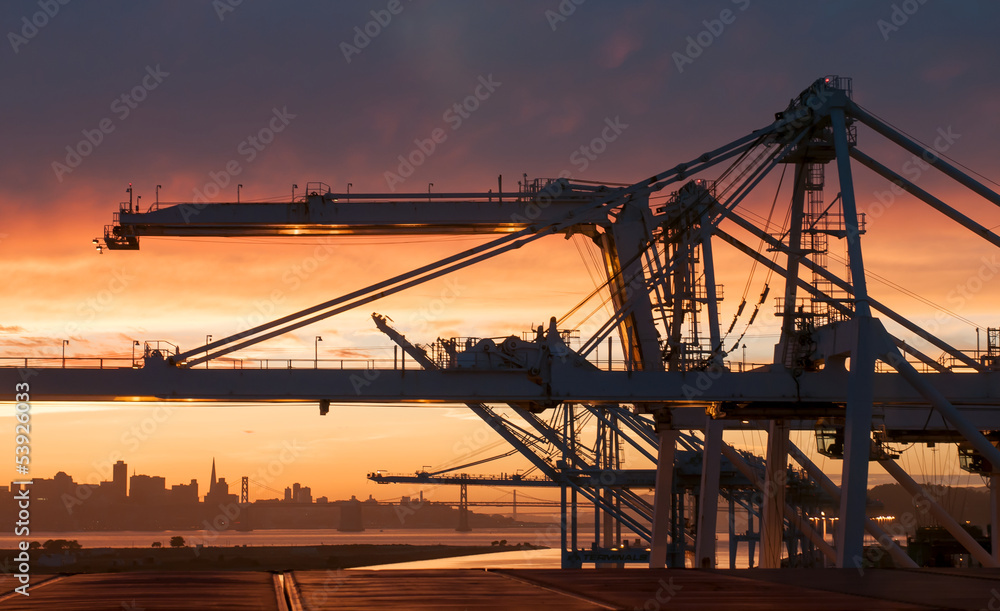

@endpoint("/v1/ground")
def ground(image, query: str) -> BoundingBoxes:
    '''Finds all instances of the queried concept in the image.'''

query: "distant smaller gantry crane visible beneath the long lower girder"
[367,426,834,568]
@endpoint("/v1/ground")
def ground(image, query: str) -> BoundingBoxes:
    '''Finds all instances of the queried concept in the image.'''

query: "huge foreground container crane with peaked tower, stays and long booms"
[7,77,1000,567]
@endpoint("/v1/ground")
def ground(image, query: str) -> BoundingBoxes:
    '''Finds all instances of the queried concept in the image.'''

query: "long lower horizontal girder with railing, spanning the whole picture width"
[0,364,1000,431]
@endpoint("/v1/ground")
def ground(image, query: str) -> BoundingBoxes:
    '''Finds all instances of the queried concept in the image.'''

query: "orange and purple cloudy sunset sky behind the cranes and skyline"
[0,0,1000,498]
